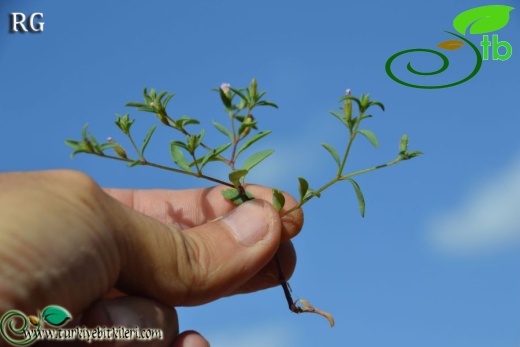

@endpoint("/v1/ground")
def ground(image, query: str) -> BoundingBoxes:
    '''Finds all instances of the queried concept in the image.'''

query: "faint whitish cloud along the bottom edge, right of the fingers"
[205,324,300,347]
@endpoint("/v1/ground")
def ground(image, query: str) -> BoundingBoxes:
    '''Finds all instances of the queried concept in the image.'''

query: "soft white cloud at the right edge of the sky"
[430,158,520,255]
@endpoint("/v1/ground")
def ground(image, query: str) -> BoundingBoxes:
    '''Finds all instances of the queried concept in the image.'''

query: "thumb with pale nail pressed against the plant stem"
[115,200,282,306]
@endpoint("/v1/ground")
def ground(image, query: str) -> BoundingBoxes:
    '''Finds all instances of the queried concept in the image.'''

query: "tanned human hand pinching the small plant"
[0,171,303,346]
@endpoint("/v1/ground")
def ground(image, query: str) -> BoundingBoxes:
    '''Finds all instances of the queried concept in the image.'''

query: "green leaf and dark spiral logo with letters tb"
[385,5,514,89]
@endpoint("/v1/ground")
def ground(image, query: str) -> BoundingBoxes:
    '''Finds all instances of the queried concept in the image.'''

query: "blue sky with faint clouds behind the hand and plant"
[0,0,520,347]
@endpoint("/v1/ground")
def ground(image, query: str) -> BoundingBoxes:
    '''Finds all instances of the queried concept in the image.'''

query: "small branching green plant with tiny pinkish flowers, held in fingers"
[65,79,422,326]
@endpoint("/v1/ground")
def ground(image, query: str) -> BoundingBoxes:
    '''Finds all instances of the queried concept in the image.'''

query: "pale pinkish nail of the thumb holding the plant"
[222,200,270,246]
